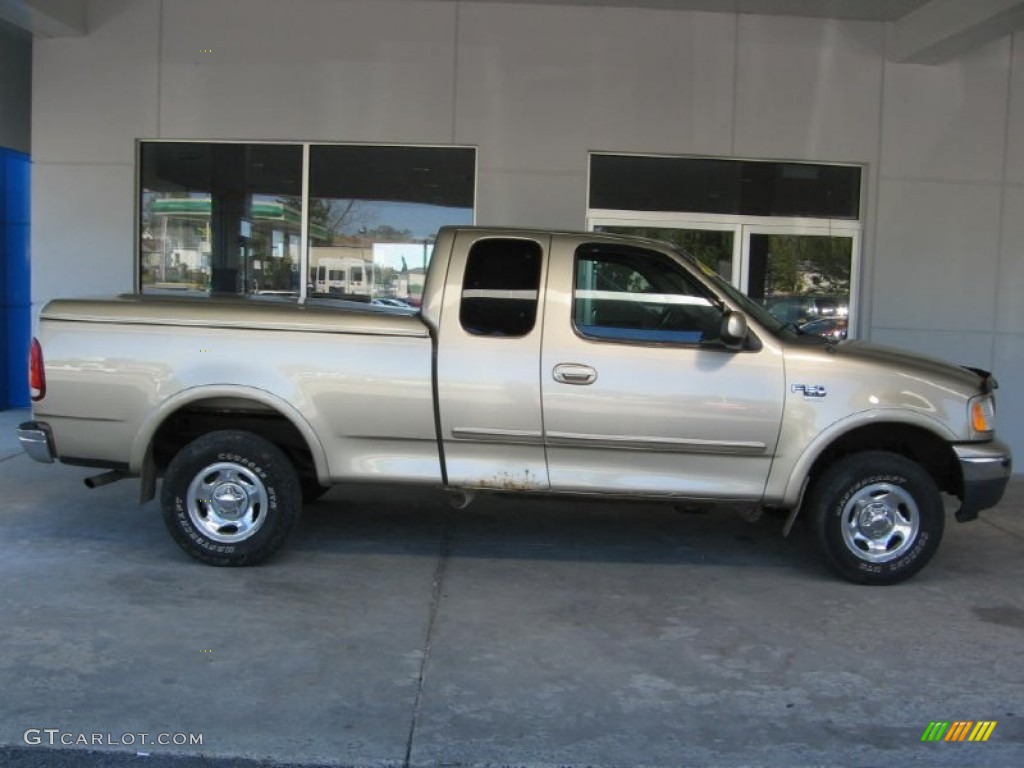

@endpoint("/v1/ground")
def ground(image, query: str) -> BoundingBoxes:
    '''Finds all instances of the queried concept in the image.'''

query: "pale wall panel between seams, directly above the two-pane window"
[161,0,455,142]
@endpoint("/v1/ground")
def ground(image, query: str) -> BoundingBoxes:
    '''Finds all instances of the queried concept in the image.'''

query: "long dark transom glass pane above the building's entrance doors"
[590,155,860,219]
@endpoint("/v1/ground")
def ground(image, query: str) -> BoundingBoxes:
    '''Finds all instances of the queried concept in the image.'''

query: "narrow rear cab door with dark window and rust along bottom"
[437,230,551,490]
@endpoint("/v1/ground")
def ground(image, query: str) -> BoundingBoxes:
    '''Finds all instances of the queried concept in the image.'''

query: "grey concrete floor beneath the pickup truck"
[0,412,1024,768]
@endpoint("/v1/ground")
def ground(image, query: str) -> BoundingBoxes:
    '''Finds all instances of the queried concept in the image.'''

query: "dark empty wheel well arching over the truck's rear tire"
[151,397,316,477]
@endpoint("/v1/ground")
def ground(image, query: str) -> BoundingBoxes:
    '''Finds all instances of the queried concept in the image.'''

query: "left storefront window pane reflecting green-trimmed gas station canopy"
[139,142,302,297]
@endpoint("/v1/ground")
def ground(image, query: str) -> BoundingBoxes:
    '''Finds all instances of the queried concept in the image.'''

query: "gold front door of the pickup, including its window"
[541,234,784,500]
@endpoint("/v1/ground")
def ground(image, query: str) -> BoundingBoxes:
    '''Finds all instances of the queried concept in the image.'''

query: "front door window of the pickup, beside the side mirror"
[572,246,722,344]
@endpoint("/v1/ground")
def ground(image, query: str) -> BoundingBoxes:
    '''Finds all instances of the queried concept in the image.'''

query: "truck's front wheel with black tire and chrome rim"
[807,451,945,586]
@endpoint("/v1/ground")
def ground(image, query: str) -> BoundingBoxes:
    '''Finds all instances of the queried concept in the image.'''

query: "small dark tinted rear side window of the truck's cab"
[459,238,543,337]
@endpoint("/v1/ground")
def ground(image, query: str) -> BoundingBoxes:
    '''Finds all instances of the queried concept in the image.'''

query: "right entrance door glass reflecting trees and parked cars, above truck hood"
[748,234,853,339]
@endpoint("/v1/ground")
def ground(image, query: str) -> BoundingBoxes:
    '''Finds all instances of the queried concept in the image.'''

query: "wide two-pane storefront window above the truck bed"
[139,141,476,304]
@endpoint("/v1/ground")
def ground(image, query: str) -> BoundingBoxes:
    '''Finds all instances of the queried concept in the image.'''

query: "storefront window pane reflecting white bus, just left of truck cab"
[307,145,476,306]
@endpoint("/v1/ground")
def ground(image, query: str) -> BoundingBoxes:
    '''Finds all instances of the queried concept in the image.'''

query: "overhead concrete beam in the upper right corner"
[889,0,1024,65]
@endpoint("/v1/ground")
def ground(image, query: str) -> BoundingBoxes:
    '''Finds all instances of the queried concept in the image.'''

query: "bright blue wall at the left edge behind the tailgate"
[0,147,32,410]
